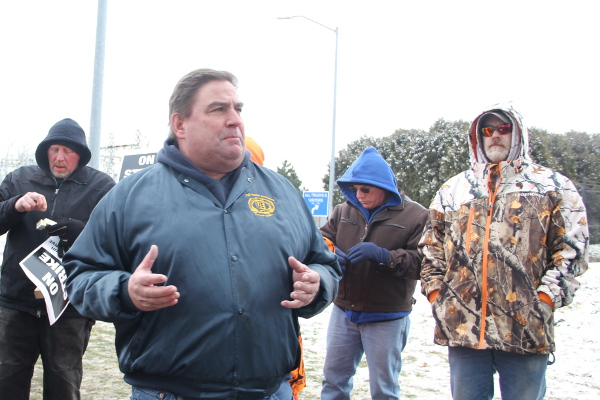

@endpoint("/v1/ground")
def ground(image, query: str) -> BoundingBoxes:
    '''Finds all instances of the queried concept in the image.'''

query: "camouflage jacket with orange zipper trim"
[420,160,589,354]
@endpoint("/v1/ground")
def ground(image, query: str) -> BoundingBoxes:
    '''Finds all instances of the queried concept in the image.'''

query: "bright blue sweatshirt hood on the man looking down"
[337,147,402,220]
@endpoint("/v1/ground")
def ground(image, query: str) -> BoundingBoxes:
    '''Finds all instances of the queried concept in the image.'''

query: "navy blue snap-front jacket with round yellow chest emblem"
[64,142,341,399]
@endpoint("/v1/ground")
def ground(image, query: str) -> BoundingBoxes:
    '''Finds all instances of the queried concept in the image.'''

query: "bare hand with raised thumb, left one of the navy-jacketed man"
[127,244,179,311]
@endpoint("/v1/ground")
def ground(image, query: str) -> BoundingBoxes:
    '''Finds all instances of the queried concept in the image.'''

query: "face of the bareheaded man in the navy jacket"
[171,81,246,179]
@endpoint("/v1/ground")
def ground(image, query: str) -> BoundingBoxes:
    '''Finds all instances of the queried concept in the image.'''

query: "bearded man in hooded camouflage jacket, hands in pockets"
[419,105,589,400]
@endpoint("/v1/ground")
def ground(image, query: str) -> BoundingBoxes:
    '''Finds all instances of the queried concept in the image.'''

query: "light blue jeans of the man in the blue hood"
[321,305,410,400]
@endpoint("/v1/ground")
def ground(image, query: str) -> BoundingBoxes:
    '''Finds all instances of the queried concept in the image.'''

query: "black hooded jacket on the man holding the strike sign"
[0,119,115,317]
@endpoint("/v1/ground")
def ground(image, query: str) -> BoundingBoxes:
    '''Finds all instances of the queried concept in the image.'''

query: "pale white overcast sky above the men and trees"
[0,0,600,190]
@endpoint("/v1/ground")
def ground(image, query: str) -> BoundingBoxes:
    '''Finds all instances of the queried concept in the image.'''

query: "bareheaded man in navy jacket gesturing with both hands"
[64,69,341,400]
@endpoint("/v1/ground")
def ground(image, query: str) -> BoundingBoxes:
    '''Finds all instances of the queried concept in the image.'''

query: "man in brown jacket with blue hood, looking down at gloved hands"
[321,147,427,400]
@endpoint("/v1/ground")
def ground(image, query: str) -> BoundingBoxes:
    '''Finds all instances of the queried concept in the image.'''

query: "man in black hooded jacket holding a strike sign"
[0,118,115,400]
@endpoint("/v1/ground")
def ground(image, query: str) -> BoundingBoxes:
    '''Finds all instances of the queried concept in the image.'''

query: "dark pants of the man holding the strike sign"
[0,306,94,400]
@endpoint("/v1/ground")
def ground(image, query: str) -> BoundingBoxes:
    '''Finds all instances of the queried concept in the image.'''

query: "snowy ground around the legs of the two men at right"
[300,250,600,400]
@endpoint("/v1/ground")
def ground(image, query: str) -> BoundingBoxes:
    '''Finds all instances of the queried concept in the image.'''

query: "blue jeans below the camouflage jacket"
[448,347,548,400]
